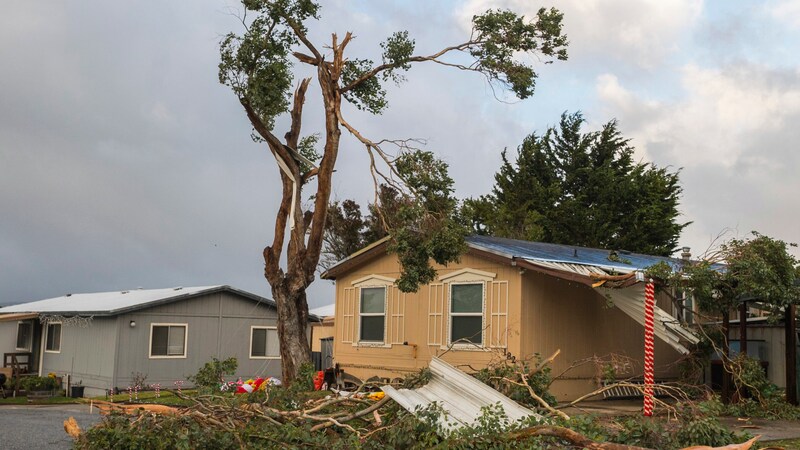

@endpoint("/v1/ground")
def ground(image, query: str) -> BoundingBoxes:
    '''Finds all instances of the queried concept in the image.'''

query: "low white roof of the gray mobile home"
[0,286,221,314]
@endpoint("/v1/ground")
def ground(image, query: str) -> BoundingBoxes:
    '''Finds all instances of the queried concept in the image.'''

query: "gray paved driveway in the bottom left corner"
[0,405,100,450]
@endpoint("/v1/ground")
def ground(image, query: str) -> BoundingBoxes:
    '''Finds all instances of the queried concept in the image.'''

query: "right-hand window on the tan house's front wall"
[450,283,483,345]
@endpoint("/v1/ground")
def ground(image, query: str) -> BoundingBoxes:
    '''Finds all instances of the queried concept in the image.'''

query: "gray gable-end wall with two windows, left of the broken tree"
[115,292,281,388]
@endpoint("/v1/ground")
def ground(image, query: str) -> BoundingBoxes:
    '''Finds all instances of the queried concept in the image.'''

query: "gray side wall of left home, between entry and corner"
[42,317,117,395]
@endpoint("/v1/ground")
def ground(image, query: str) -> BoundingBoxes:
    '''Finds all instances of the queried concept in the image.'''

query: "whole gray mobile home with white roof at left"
[0,286,300,395]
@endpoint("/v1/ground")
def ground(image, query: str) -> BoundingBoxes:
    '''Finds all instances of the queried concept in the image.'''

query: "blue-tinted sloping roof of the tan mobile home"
[467,236,683,272]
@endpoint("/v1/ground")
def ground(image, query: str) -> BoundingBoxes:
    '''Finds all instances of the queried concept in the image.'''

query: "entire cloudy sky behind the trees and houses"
[0,0,800,307]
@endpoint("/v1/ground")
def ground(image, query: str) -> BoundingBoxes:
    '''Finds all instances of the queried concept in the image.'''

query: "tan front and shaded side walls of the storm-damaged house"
[328,250,679,401]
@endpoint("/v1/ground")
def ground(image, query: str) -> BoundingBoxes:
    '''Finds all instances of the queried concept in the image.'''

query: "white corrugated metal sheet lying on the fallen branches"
[382,356,541,430]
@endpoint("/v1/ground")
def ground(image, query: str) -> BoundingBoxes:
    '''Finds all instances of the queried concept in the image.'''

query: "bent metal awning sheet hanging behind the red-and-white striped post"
[600,283,699,355]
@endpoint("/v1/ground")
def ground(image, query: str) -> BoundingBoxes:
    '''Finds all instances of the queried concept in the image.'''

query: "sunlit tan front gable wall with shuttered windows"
[334,251,520,379]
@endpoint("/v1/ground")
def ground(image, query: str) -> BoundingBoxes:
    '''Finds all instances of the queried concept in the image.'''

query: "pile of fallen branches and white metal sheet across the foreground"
[64,352,758,450]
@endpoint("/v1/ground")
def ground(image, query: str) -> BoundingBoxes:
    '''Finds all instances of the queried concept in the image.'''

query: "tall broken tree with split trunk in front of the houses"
[219,0,567,382]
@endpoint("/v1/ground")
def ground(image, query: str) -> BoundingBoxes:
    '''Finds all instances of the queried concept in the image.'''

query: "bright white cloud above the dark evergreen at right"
[596,62,800,253]
